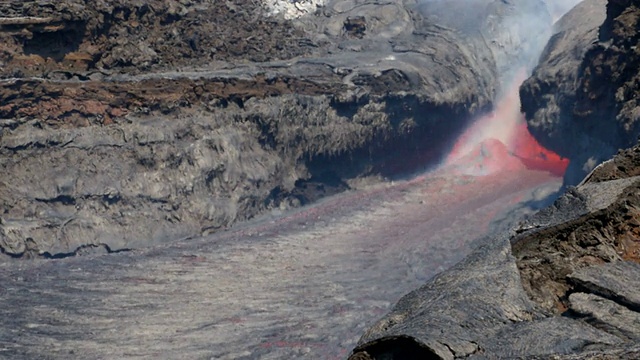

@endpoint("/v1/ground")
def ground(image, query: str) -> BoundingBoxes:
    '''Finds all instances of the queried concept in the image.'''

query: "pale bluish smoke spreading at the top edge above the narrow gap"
[417,0,580,84]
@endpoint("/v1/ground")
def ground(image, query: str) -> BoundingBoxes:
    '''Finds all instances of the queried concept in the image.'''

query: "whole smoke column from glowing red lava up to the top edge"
[436,0,580,176]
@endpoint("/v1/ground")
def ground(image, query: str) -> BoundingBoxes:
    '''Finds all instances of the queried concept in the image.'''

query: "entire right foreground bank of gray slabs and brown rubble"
[350,141,640,359]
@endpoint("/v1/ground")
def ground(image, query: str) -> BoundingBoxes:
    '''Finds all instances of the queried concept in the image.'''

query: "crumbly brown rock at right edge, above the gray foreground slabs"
[514,178,640,311]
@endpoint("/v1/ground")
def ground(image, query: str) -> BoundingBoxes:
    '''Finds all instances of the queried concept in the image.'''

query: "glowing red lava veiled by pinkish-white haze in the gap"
[444,76,569,176]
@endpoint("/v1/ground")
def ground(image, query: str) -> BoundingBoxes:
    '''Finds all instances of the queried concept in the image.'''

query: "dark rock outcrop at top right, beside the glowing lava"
[520,0,640,185]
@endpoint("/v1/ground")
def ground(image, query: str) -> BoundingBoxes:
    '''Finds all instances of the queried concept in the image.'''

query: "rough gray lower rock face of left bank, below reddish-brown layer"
[1,74,470,254]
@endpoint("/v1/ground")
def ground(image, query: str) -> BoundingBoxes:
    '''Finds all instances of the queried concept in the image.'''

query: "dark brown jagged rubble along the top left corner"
[0,0,315,74]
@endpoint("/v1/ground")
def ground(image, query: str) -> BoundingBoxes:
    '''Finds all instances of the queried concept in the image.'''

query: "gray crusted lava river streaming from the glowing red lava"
[0,171,559,360]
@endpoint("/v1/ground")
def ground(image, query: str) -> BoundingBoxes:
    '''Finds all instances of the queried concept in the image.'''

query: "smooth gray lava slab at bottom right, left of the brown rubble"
[352,232,621,359]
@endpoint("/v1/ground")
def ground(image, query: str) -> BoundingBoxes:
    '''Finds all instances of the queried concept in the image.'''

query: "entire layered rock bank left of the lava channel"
[0,0,549,257]
